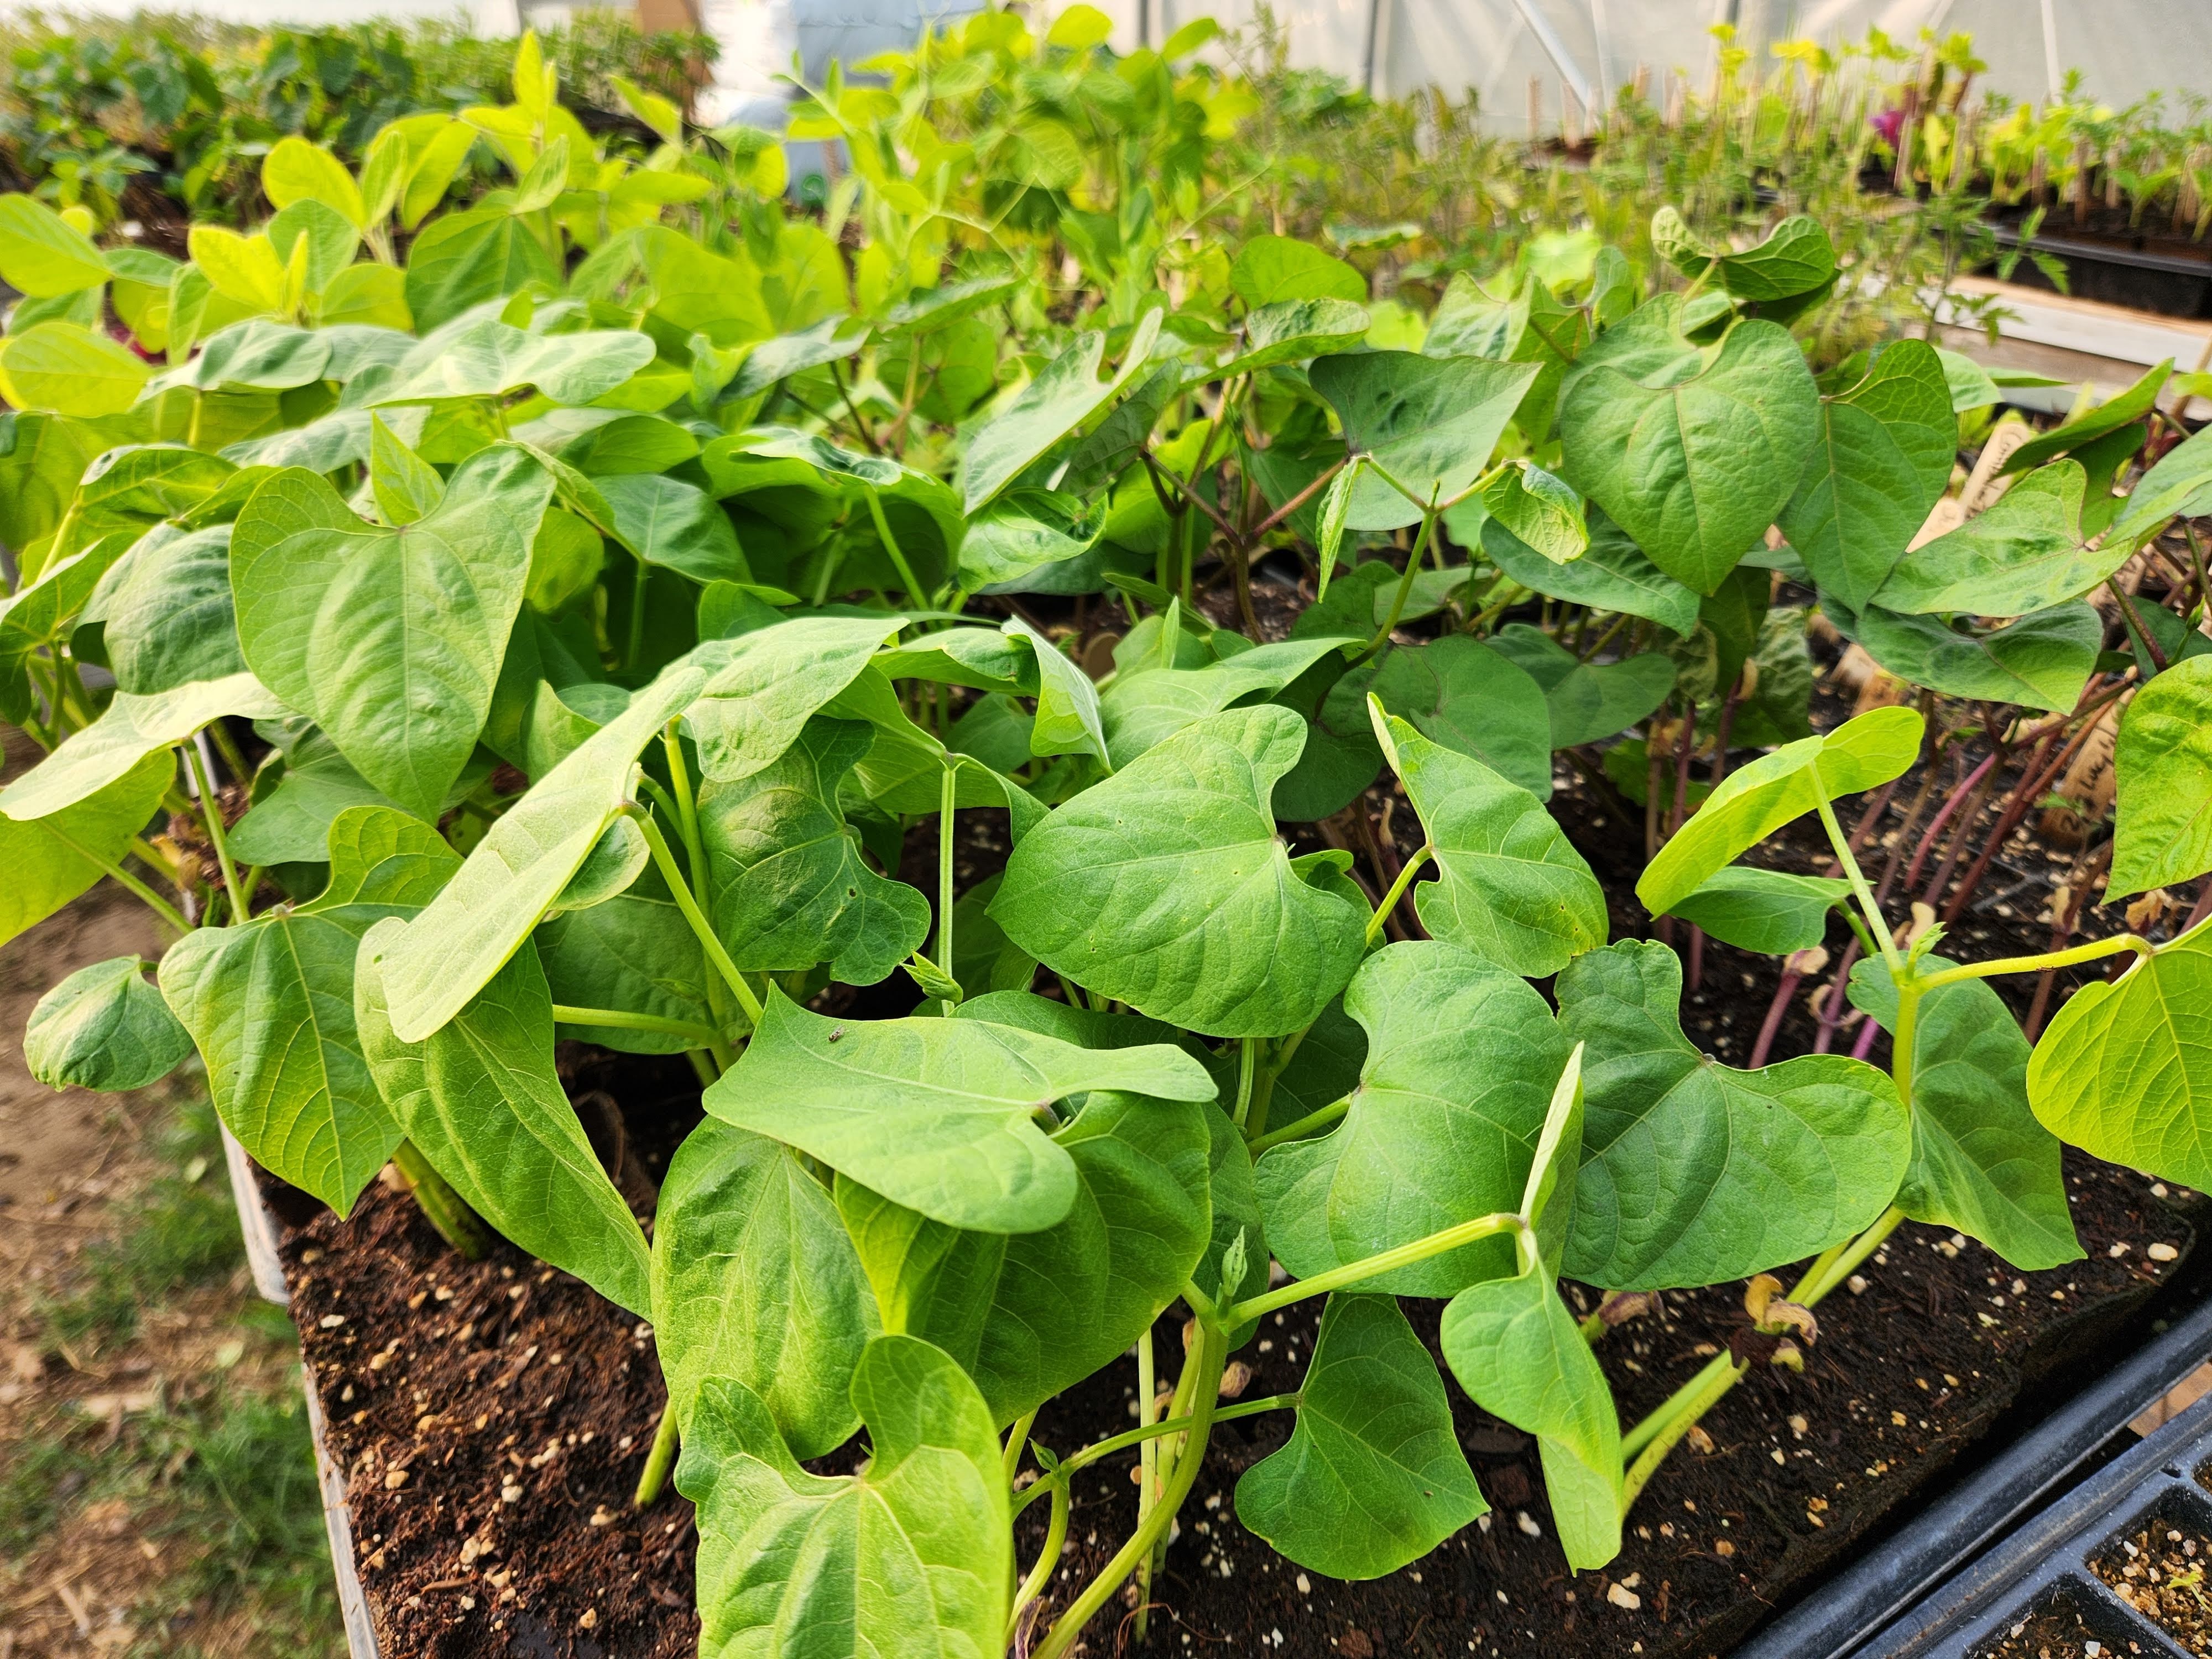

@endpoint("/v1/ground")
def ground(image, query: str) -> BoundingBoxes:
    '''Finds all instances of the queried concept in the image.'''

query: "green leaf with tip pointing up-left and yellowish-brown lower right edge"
[1376,717,1606,980]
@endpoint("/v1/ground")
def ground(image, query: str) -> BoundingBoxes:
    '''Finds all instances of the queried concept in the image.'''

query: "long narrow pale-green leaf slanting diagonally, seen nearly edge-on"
[383,661,706,1042]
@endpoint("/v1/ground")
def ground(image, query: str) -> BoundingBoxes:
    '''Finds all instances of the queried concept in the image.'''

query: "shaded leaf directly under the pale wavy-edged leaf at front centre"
[836,1093,1212,1425]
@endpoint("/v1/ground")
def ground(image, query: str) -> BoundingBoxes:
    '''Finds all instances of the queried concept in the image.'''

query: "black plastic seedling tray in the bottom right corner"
[1736,1303,2212,1659]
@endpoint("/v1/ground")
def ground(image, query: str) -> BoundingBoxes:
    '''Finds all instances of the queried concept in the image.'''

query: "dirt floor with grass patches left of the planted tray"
[0,732,345,1659]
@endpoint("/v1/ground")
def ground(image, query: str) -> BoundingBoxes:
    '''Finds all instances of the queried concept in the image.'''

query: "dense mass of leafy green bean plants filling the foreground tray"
[0,24,2212,1659]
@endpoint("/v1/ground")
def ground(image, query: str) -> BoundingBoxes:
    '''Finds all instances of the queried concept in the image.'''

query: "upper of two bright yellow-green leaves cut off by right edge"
[2106,655,2212,898]
